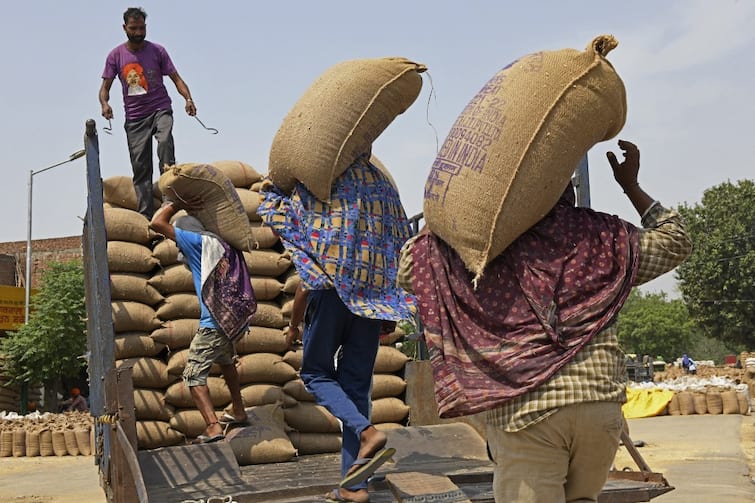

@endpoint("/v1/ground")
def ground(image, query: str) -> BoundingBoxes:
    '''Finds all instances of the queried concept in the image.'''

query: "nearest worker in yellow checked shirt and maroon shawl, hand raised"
[399,140,692,503]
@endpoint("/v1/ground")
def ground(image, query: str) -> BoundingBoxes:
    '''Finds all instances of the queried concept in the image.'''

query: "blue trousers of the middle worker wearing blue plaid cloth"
[301,289,382,489]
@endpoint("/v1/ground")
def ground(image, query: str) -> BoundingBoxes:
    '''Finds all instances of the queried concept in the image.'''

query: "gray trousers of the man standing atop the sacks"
[123,110,176,219]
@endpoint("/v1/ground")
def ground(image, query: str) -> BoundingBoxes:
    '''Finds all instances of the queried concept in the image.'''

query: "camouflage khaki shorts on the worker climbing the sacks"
[183,327,236,387]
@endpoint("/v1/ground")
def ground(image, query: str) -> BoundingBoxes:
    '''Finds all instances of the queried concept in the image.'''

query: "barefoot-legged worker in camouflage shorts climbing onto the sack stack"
[150,202,257,444]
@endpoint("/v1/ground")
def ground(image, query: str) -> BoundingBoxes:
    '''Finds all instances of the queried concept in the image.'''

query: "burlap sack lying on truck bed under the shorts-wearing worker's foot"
[226,405,296,466]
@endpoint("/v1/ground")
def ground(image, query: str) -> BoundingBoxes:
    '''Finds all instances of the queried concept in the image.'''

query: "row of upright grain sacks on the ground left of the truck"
[0,412,94,457]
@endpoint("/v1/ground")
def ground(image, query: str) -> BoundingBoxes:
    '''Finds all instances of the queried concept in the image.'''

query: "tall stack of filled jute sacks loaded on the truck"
[103,161,416,464]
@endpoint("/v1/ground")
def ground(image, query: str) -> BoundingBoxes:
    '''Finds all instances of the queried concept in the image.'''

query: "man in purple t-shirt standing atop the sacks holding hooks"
[100,7,197,219]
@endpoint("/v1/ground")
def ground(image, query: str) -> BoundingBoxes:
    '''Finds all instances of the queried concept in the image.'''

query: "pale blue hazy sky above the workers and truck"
[0,0,755,297]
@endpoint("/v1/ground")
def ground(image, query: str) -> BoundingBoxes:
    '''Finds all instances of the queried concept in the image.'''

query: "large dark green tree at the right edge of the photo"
[677,180,755,347]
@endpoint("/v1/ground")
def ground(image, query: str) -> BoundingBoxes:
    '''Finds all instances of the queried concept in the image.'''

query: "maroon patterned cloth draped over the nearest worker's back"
[411,186,639,417]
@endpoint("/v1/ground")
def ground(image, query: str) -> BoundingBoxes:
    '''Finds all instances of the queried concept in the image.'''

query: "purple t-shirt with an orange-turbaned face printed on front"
[102,41,177,121]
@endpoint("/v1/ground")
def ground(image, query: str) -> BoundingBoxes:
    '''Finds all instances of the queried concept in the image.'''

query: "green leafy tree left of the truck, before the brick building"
[0,261,87,382]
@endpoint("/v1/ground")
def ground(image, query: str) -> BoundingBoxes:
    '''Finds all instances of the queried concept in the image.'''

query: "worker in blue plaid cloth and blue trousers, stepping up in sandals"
[258,155,413,502]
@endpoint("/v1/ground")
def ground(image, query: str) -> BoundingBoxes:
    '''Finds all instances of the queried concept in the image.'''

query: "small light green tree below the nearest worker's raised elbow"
[618,288,696,358]
